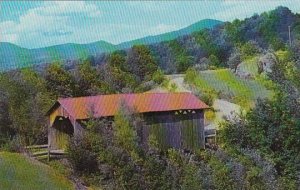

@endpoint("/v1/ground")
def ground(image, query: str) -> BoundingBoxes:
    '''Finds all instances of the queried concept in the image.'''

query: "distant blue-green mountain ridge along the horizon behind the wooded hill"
[0,19,222,71]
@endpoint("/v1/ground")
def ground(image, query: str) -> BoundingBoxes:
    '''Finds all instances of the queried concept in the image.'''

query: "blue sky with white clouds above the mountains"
[0,0,300,48]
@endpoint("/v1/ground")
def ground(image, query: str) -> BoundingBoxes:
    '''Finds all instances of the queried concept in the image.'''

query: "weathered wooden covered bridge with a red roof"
[47,93,208,149]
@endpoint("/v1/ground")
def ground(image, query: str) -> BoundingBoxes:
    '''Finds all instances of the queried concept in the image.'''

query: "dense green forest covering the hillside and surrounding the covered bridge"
[0,7,300,190]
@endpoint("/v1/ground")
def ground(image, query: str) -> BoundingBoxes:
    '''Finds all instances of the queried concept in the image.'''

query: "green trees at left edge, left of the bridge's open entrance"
[0,69,52,144]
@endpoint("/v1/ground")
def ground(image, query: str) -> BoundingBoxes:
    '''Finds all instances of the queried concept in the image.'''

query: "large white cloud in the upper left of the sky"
[0,1,102,46]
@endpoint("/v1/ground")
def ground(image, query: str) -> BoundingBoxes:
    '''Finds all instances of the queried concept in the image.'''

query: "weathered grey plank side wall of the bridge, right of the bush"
[142,110,205,150]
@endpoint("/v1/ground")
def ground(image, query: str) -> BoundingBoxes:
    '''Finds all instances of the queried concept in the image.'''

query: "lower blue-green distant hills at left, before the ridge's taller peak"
[0,41,117,71]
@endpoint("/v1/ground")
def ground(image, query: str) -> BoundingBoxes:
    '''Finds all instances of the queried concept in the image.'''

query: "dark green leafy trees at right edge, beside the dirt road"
[220,64,300,184]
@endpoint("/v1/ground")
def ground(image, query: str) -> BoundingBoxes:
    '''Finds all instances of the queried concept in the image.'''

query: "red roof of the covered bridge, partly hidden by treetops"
[54,92,209,119]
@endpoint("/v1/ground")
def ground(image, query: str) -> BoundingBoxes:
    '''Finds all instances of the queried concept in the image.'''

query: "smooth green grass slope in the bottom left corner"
[0,152,74,190]
